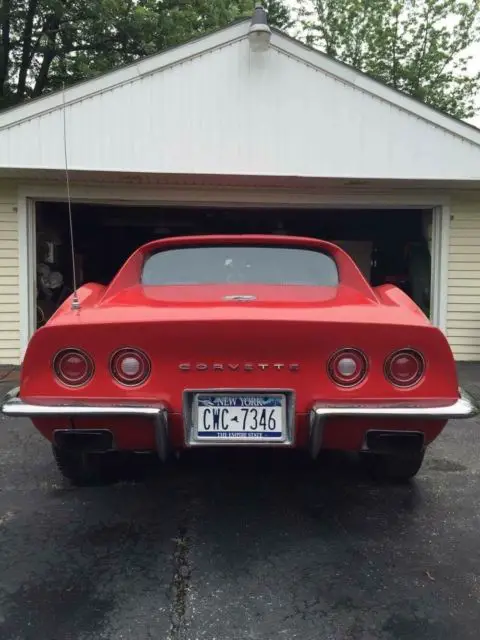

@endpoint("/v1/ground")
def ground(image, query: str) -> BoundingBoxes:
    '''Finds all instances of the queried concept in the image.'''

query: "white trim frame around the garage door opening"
[18,186,450,359]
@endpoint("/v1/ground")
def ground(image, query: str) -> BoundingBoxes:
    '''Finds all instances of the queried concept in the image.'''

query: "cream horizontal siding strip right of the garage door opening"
[447,194,480,360]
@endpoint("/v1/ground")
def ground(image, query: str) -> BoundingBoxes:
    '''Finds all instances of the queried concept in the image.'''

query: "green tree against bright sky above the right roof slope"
[298,0,480,118]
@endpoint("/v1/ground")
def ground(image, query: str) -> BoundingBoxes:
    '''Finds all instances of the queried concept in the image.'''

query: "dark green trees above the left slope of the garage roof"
[0,0,290,109]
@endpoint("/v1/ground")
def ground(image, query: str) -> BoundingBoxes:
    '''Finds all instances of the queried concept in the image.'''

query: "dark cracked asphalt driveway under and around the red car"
[0,366,480,640]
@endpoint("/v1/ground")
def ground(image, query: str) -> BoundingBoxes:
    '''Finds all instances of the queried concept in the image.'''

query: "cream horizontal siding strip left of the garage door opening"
[0,181,20,365]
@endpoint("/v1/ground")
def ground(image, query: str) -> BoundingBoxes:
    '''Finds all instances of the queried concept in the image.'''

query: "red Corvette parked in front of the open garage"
[2,235,478,483]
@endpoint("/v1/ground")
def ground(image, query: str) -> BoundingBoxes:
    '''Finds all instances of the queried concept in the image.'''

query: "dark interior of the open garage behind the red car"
[35,202,432,327]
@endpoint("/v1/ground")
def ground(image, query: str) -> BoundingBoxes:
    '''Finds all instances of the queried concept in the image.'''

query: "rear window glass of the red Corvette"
[141,246,338,287]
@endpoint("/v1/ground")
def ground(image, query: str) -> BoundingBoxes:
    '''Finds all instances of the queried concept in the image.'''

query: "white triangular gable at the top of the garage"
[0,22,480,180]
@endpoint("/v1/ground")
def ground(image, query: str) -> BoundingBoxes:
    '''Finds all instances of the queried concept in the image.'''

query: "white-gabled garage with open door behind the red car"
[0,13,480,366]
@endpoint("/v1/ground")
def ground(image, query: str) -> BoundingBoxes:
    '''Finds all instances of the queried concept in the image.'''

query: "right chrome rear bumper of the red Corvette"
[309,388,480,458]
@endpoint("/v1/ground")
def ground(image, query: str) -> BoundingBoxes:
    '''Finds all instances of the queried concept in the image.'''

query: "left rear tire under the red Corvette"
[52,445,110,486]
